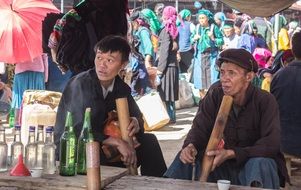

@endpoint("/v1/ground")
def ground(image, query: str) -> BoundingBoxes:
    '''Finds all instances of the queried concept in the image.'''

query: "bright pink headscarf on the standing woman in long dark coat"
[162,6,179,39]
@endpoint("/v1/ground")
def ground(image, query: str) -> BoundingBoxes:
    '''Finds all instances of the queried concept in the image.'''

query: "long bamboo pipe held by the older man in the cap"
[200,95,233,182]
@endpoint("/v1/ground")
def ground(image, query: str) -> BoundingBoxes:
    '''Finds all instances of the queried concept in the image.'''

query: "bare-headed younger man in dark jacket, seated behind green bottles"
[54,36,166,177]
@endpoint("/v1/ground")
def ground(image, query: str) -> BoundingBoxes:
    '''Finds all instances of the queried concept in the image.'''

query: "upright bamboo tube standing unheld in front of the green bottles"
[86,141,101,190]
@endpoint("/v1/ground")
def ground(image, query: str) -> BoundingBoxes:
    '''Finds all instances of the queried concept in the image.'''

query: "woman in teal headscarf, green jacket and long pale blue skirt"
[191,9,224,97]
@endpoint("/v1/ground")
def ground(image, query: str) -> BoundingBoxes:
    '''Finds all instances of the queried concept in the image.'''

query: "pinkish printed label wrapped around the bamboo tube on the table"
[86,142,100,168]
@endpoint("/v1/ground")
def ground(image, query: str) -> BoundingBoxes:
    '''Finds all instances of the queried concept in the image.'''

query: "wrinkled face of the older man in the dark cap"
[220,62,253,98]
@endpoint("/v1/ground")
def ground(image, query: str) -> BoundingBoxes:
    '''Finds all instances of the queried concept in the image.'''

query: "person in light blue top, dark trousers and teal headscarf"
[177,9,195,73]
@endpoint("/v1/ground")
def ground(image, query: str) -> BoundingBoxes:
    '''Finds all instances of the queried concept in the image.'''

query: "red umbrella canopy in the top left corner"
[0,0,59,63]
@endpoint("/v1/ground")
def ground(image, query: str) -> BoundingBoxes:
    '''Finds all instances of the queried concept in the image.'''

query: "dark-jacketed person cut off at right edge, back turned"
[271,32,301,156]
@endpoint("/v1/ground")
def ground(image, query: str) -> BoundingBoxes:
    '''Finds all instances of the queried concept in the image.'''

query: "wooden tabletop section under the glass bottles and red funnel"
[0,166,128,190]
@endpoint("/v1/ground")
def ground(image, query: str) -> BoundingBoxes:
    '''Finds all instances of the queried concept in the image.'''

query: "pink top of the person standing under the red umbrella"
[15,53,48,82]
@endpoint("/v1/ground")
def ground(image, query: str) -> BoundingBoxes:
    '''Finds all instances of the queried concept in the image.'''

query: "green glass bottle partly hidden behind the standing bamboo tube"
[77,108,93,175]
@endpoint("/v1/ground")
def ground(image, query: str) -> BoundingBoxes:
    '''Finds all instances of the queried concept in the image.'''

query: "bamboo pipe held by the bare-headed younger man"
[116,98,138,175]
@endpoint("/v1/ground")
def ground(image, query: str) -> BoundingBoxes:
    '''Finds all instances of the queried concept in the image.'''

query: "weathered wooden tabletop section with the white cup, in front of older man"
[105,176,270,190]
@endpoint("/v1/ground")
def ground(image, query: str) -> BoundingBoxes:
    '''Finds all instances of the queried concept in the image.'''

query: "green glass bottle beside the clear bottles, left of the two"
[60,112,77,176]
